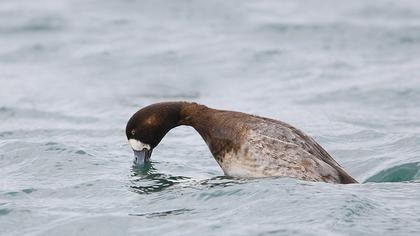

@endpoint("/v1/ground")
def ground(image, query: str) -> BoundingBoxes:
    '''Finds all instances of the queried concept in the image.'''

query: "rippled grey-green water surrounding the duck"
[0,0,420,235]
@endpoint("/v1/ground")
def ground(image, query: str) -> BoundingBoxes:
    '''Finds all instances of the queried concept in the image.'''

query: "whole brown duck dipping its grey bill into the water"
[126,101,357,184]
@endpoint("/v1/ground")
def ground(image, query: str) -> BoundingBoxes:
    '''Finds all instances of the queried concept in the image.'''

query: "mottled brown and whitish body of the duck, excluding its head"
[127,103,357,184]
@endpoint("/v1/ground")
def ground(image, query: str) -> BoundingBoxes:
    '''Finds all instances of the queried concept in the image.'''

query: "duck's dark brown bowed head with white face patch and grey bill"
[125,102,204,164]
